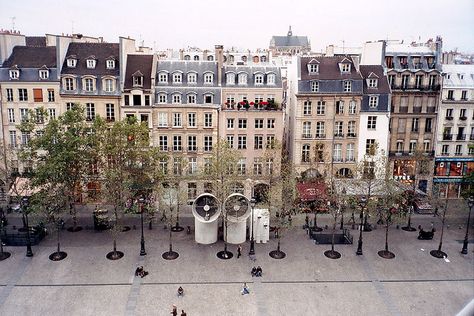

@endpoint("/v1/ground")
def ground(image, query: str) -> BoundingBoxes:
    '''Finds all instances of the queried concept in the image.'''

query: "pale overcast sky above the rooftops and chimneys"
[0,0,474,53]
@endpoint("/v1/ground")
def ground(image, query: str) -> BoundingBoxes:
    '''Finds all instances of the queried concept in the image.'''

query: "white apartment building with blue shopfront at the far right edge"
[433,64,474,198]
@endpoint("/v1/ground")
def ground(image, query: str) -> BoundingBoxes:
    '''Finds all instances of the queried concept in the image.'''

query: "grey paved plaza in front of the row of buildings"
[0,206,474,316]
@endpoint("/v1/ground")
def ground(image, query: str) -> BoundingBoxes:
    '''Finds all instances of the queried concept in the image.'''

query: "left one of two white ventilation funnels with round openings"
[192,193,221,245]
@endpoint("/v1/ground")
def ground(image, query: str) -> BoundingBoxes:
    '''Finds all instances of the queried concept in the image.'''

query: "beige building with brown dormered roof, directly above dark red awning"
[287,56,364,177]
